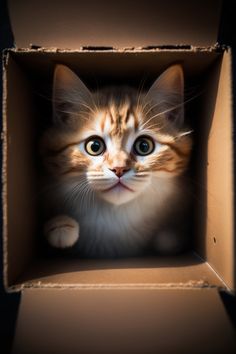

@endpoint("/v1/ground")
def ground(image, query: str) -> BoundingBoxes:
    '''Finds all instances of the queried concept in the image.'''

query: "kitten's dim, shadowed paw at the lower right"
[153,230,184,255]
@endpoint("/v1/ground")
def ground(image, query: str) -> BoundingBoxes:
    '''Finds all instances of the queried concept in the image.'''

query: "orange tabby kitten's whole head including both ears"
[43,65,191,205]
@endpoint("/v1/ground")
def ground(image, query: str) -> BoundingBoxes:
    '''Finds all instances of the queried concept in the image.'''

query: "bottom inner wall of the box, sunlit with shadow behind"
[15,253,225,289]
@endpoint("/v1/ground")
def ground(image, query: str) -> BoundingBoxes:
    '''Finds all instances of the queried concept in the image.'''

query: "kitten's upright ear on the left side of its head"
[53,64,91,123]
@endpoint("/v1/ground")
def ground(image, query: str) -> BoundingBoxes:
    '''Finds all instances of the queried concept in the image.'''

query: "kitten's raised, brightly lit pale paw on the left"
[44,215,79,248]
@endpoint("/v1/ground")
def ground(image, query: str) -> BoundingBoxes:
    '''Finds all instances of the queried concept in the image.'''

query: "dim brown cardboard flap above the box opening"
[9,0,221,49]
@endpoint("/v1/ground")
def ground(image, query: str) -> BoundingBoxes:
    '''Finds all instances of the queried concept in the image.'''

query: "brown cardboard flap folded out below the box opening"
[13,289,236,354]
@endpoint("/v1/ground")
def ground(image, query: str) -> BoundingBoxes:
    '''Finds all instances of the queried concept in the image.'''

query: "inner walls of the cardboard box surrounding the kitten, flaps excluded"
[3,48,234,289]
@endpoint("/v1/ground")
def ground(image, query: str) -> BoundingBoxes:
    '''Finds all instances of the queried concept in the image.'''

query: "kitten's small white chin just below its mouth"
[100,186,139,205]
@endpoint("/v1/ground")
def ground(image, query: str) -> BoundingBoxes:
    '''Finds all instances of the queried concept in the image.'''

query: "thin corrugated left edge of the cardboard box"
[1,50,9,292]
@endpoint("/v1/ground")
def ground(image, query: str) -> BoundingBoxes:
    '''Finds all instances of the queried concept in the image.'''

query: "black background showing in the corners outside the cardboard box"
[0,0,236,354]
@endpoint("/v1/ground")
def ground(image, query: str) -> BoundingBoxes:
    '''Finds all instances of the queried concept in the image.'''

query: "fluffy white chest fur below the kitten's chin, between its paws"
[73,179,181,256]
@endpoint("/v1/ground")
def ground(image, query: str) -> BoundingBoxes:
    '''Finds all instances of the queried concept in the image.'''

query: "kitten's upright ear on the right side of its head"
[146,64,184,126]
